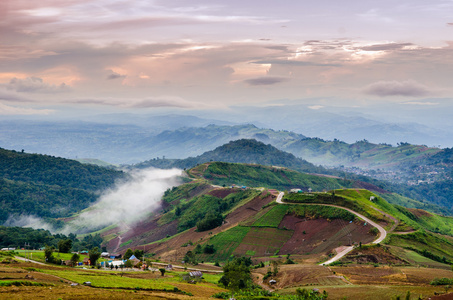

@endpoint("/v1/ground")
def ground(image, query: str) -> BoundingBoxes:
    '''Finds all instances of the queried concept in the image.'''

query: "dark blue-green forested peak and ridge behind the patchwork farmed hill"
[133,139,453,214]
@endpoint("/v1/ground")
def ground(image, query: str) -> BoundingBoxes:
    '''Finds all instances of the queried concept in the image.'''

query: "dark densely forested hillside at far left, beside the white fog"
[0,148,127,223]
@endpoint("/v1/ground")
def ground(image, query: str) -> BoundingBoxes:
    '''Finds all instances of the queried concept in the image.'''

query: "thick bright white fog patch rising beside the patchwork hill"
[63,168,182,233]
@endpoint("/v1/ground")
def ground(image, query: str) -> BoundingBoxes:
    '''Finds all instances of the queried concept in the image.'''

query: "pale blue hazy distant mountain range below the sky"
[0,103,453,164]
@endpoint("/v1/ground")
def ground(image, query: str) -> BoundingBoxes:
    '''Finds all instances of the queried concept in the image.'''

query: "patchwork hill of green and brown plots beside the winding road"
[114,162,453,268]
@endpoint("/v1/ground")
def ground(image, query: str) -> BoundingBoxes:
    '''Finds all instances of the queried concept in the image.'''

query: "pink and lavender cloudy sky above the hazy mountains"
[0,0,453,116]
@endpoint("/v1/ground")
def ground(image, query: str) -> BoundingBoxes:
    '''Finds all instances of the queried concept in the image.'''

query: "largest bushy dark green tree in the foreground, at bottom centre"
[219,258,252,291]
